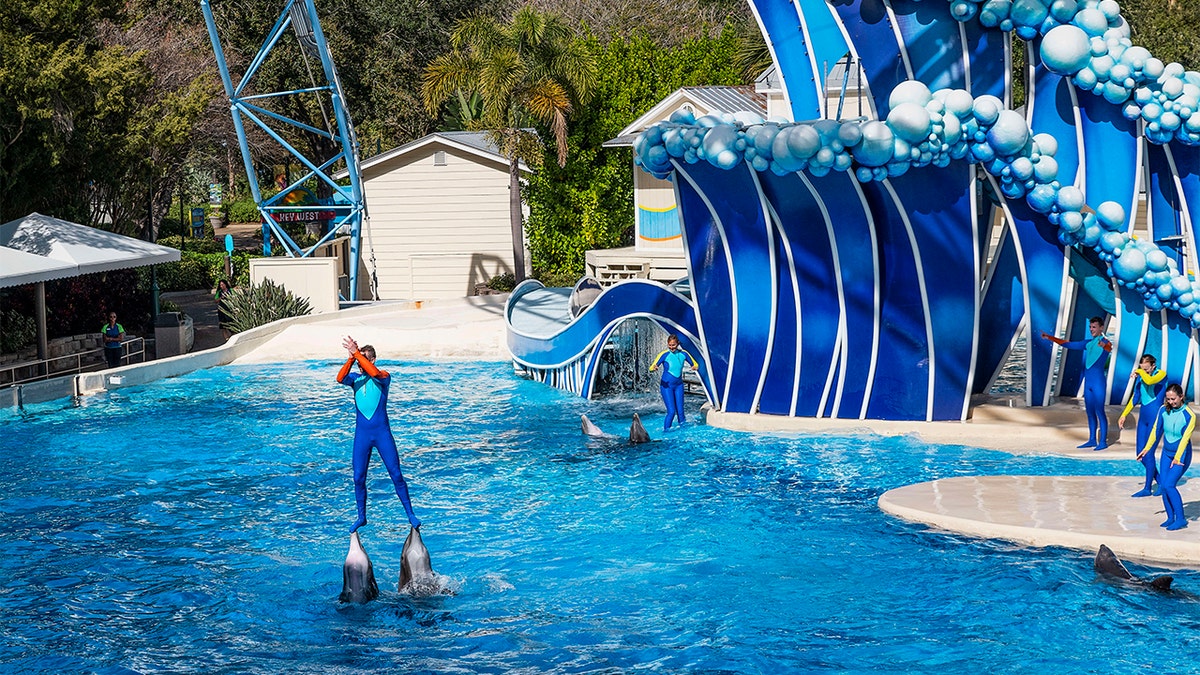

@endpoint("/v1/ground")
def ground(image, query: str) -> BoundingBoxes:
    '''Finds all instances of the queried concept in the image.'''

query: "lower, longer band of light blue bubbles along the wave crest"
[634,74,1200,328]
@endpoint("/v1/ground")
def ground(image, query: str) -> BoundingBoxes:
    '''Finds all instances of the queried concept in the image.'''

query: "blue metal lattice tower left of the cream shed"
[200,0,374,300]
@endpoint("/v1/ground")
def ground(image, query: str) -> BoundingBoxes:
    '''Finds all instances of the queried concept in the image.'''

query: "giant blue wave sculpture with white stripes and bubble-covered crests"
[501,0,1200,419]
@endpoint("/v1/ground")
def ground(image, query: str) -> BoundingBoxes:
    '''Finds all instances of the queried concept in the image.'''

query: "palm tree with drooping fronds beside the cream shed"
[421,5,598,282]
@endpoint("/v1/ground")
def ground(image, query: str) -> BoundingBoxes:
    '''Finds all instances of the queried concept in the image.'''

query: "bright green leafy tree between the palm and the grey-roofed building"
[528,25,744,279]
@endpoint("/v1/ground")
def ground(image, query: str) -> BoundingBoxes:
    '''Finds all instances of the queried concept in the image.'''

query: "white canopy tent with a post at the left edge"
[0,213,179,367]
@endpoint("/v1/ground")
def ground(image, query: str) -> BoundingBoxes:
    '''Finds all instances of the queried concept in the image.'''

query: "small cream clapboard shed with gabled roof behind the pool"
[350,131,530,300]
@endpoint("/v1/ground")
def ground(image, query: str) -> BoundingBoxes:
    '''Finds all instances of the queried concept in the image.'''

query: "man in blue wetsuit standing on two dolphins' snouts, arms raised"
[337,338,421,532]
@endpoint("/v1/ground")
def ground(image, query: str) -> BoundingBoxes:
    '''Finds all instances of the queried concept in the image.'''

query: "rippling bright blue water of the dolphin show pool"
[0,363,1200,673]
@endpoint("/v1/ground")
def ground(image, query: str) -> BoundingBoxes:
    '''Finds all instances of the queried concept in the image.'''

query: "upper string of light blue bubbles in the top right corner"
[950,0,1200,145]
